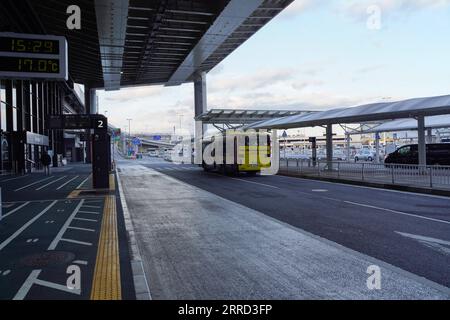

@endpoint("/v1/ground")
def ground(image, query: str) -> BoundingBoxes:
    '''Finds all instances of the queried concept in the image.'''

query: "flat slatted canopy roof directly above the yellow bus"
[195,109,308,124]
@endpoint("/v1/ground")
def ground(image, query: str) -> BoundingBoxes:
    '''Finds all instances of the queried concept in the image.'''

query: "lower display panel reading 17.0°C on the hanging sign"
[0,57,60,74]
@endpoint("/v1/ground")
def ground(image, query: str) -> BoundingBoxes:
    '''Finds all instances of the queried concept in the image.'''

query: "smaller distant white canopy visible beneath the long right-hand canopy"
[361,115,450,133]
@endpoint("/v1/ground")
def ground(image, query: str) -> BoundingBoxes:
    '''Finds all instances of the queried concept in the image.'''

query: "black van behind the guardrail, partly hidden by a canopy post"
[384,143,450,165]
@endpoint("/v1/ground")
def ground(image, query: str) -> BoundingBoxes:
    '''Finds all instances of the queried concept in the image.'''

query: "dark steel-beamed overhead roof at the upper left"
[0,0,293,90]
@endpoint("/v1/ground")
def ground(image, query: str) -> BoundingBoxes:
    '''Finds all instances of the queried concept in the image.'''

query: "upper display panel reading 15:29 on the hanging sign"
[0,37,59,54]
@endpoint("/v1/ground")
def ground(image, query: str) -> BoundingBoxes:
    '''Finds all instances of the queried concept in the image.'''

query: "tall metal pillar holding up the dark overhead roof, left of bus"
[194,72,208,164]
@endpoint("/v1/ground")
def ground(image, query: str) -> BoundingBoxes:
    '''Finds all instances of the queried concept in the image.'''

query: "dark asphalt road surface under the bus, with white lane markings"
[131,158,450,287]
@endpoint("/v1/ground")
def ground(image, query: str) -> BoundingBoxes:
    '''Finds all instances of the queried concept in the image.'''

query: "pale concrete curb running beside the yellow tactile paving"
[116,170,152,300]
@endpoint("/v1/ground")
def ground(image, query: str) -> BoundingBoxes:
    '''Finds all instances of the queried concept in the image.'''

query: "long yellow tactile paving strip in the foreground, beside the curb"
[91,196,122,300]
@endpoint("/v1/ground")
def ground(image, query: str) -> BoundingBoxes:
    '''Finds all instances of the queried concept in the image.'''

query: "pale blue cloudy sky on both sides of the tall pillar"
[99,0,450,133]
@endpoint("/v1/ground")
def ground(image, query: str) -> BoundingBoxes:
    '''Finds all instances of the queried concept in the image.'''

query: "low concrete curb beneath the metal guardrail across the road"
[278,172,450,197]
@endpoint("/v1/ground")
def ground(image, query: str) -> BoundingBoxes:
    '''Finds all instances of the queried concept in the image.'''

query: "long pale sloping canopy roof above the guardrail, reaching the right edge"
[247,95,450,129]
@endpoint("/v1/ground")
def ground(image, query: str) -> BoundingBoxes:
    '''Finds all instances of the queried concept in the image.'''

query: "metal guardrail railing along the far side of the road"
[280,159,450,190]
